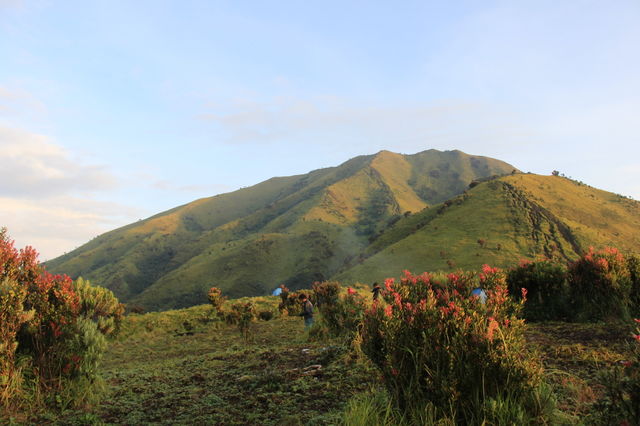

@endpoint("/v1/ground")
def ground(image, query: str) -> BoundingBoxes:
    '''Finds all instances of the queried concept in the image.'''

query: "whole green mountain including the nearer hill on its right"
[47,150,640,310]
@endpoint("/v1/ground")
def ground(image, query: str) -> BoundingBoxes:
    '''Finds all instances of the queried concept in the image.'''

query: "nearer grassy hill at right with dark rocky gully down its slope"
[335,174,640,282]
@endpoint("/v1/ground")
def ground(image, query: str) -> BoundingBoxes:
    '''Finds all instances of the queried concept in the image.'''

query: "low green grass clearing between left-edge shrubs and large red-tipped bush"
[34,297,377,425]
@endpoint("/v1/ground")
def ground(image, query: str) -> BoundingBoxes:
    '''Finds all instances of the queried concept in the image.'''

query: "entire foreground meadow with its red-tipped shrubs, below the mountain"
[0,225,640,425]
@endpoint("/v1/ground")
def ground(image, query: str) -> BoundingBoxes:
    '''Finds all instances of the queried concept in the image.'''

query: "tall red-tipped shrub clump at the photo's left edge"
[0,230,124,413]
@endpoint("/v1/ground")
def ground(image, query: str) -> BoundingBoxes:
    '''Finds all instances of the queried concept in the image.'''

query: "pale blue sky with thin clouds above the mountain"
[0,0,640,260]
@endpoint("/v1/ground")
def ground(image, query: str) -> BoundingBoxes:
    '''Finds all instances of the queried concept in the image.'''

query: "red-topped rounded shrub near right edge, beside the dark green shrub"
[568,247,631,321]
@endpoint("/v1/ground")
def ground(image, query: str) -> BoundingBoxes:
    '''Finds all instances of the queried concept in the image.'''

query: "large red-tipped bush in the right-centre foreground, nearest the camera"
[362,265,542,424]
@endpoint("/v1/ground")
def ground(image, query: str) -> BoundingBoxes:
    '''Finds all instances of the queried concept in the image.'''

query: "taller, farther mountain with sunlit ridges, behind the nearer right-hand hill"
[46,150,521,310]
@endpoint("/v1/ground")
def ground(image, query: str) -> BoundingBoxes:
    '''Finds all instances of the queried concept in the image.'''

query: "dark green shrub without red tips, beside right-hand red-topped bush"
[507,260,569,321]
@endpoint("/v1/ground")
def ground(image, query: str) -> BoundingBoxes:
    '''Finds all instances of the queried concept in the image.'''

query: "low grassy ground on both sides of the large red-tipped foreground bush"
[32,297,630,425]
